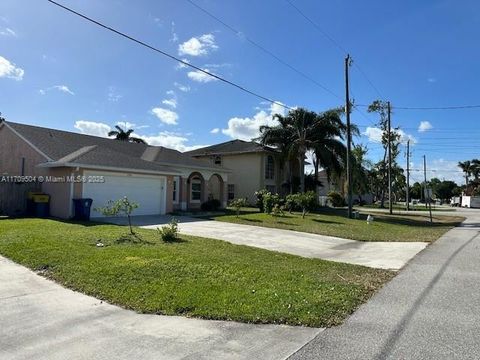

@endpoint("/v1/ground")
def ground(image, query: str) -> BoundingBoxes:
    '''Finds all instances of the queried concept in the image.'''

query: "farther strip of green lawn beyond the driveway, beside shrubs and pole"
[211,208,465,242]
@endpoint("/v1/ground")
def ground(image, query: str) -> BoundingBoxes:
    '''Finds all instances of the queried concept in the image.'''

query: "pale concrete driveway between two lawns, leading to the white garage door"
[102,216,428,270]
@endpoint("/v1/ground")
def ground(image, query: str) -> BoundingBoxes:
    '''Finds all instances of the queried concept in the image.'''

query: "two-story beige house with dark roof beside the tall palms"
[185,140,285,204]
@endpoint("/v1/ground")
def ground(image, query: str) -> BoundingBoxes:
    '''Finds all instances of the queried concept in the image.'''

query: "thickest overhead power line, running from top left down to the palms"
[47,0,293,110]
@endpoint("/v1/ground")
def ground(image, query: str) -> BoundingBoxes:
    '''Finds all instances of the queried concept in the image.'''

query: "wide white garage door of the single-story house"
[83,171,166,217]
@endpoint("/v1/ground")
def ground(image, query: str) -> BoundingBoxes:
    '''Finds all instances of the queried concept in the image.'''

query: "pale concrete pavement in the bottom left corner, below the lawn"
[0,257,321,360]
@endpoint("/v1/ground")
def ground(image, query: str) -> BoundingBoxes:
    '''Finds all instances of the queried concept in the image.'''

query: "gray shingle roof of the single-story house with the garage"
[6,122,226,173]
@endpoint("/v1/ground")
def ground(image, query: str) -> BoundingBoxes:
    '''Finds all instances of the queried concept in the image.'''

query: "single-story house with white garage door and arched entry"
[0,121,229,218]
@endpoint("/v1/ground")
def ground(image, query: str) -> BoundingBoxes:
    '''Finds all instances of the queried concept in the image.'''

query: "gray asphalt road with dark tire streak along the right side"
[292,209,480,360]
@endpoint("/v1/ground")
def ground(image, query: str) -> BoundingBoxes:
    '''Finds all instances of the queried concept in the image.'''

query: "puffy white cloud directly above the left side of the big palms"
[222,104,285,141]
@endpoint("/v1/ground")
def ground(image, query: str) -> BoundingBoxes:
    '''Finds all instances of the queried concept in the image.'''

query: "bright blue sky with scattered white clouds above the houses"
[0,0,480,182]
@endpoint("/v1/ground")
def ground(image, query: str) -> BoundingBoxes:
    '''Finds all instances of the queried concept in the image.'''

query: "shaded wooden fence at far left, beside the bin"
[0,182,41,216]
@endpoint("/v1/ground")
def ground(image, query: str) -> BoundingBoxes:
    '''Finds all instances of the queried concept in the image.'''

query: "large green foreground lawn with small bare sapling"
[0,219,394,327]
